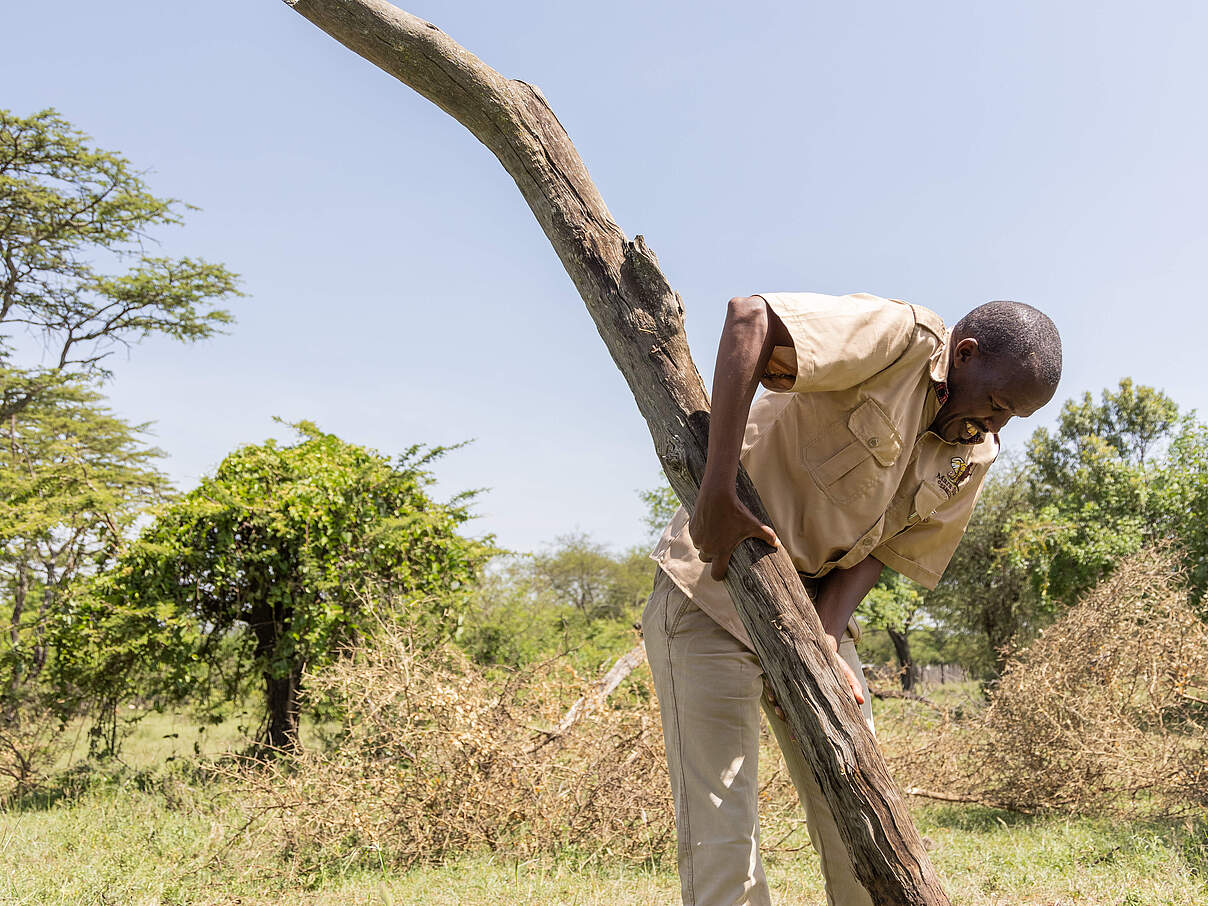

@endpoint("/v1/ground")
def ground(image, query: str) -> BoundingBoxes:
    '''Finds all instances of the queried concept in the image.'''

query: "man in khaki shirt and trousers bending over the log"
[641,292,1062,906]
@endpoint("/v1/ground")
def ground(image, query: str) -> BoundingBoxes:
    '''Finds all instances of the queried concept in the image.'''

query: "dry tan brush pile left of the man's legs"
[230,628,673,866]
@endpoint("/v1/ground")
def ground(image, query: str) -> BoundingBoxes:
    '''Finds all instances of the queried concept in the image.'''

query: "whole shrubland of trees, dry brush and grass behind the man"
[0,112,1208,906]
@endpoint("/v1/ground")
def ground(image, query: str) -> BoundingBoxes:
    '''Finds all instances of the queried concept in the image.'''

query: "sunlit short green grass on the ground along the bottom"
[0,714,1208,906]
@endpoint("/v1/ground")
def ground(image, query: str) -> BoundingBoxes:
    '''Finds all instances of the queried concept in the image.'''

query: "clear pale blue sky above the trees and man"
[0,0,1208,550]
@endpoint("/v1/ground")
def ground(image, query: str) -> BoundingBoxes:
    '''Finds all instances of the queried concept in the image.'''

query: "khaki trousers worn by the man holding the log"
[641,570,872,906]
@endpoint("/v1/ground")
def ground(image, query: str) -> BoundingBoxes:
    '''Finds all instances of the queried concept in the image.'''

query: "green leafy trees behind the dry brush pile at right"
[884,378,1208,680]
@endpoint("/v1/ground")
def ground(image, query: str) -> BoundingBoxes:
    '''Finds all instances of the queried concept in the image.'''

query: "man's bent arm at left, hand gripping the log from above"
[689,296,792,582]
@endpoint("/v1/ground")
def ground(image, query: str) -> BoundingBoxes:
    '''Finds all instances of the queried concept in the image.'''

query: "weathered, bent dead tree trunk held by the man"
[285,0,948,906]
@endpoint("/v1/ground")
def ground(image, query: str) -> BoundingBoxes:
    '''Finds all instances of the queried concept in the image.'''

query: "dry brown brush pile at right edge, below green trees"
[888,548,1208,817]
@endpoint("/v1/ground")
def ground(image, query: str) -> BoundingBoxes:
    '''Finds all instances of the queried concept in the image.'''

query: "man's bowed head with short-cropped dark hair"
[931,302,1061,443]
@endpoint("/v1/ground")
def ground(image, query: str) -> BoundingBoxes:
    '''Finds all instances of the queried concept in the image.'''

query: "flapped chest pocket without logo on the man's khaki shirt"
[805,400,902,504]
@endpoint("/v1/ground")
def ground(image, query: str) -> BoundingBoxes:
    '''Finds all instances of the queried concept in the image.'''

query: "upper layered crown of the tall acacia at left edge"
[0,110,237,418]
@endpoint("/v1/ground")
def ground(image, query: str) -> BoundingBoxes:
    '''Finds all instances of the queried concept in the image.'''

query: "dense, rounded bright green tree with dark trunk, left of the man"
[65,423,490,748]
